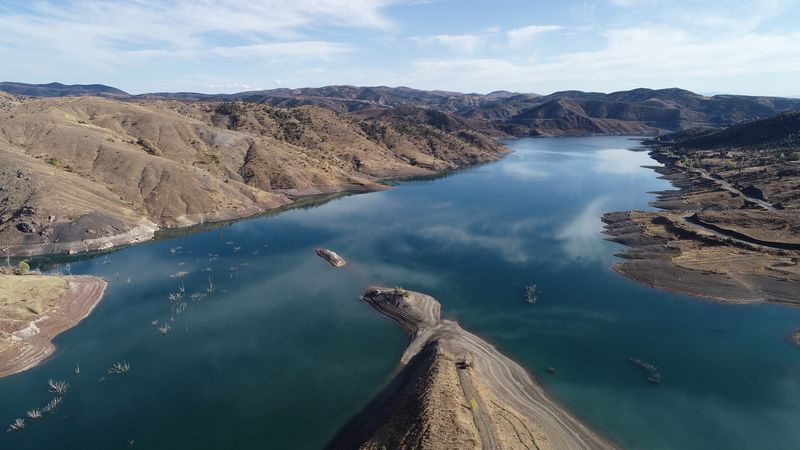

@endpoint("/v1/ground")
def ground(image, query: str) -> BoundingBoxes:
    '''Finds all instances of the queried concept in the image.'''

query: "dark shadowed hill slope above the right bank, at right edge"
[651,112,800,151]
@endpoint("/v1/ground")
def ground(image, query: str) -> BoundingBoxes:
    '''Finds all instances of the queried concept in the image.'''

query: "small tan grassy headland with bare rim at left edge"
[0,266,106,377]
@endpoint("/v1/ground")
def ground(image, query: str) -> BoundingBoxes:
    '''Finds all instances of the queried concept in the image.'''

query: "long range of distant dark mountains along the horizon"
[6,83,800,137]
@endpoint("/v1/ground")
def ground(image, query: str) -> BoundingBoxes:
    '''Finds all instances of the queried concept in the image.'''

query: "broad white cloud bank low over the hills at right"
[406,26,800,91]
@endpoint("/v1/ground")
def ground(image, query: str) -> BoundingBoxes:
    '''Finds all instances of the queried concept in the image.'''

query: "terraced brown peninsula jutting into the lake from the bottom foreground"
[330,287,613,449]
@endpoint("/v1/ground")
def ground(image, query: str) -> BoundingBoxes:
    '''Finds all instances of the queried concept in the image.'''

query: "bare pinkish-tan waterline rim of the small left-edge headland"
[0,276,107,377]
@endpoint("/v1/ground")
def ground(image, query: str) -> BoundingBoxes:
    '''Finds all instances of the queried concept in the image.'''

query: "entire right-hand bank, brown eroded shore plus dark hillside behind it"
[603,113,800,306]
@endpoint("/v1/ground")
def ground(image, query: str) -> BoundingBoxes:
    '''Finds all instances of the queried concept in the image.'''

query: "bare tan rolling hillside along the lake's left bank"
[0,95,506,254]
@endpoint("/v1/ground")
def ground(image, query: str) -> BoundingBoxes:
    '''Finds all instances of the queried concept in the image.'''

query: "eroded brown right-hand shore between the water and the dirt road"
[602,145,800,306]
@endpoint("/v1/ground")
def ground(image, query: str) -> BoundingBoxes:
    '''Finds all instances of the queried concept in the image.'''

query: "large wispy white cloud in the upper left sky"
[0,0,398,74]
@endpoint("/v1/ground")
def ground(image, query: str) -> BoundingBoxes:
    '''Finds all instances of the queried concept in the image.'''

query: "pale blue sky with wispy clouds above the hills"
[0,0,800,96]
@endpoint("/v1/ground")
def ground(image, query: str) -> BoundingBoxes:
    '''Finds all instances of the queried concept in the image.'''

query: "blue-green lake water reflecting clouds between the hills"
[0,137,800,450]
